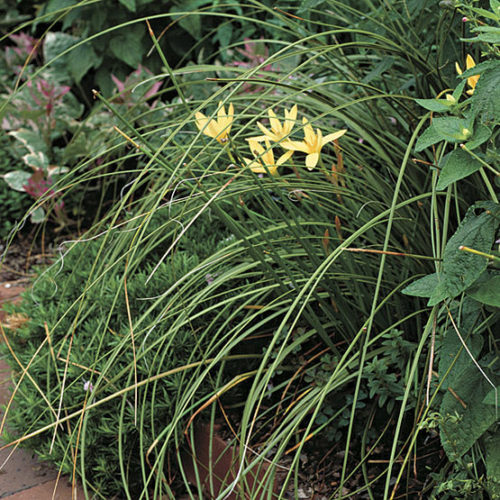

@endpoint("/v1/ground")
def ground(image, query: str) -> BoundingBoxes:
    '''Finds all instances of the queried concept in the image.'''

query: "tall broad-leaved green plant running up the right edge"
[403,0,500,498]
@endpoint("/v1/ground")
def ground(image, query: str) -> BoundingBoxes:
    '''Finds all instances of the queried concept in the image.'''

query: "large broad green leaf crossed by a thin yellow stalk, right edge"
[428,202,500,306]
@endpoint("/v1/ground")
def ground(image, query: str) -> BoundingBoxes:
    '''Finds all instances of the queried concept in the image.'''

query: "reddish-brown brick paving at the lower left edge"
[0,282,85,500]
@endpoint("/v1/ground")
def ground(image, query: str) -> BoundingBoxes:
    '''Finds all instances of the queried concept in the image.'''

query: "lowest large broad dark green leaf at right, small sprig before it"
[439,362,496,462]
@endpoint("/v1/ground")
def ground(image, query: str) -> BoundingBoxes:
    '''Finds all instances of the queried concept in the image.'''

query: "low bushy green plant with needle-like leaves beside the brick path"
[2,210,235,498]
